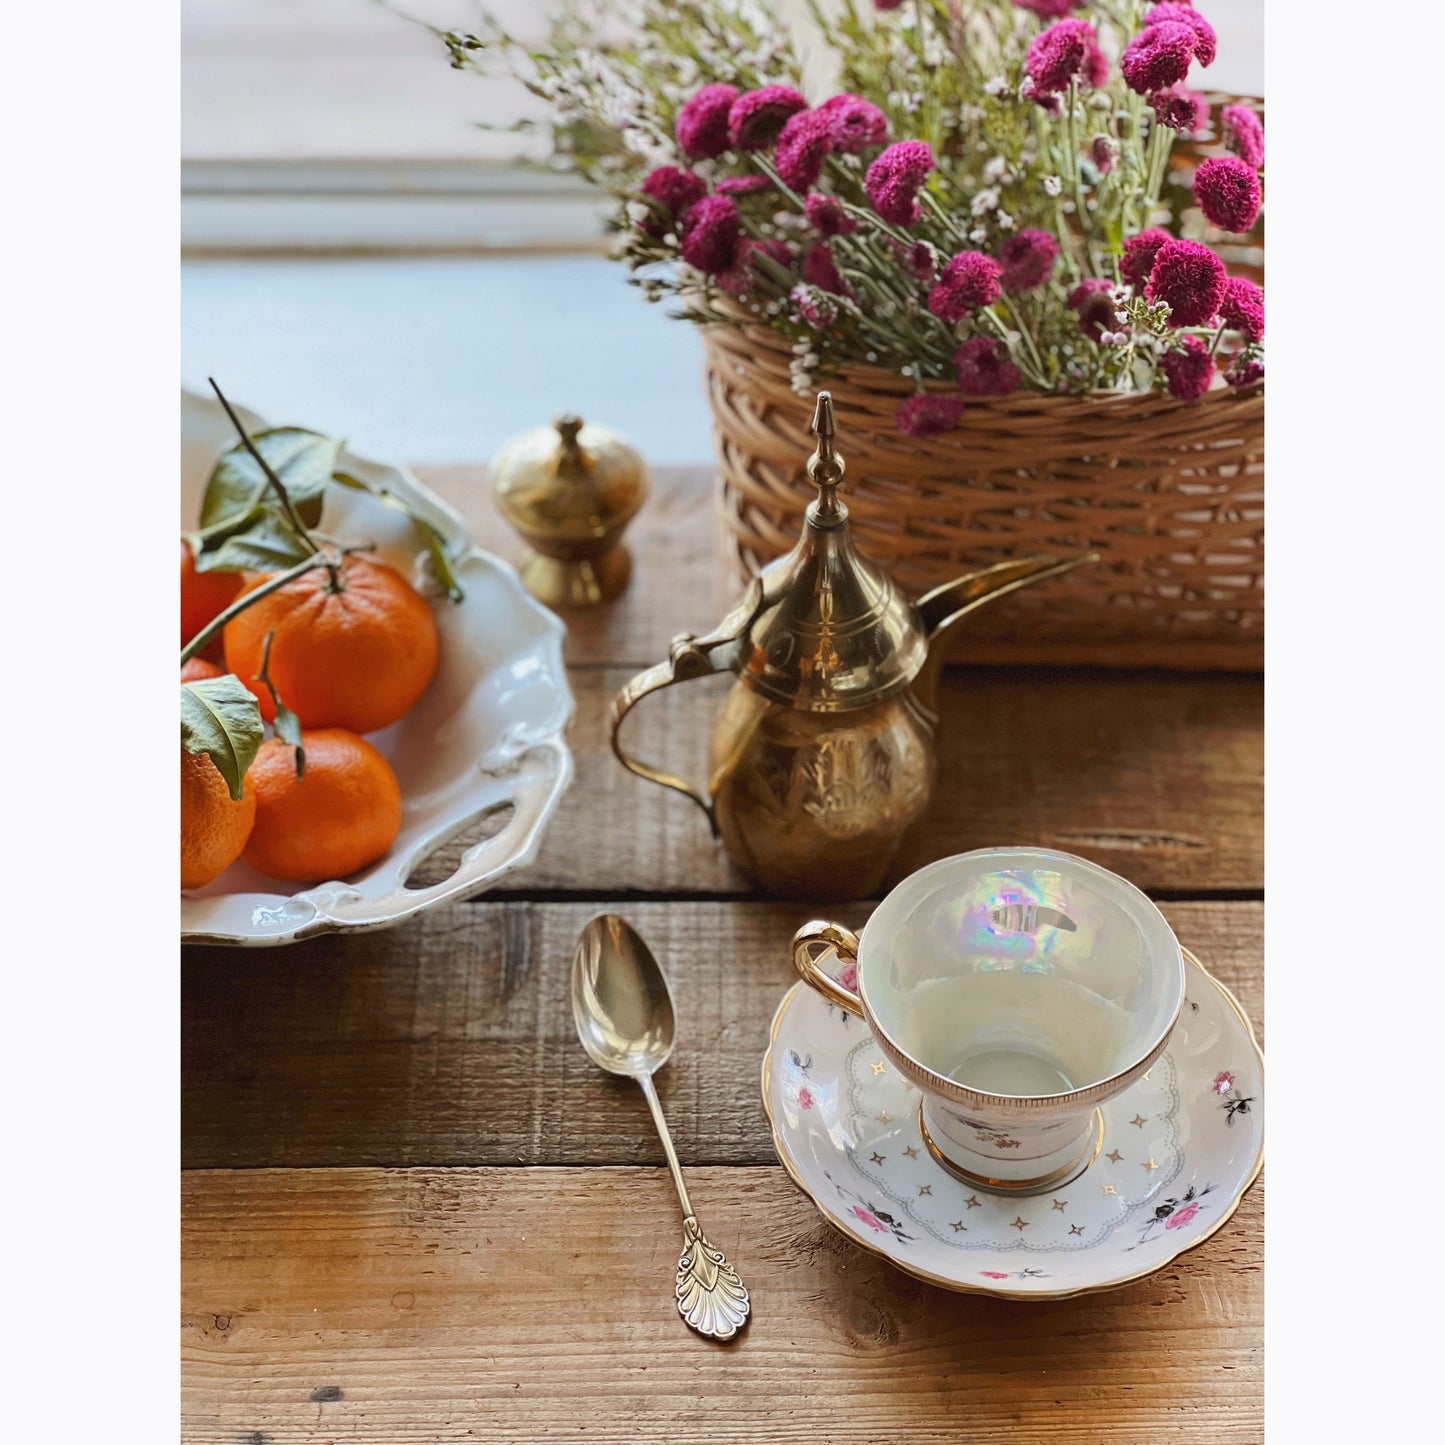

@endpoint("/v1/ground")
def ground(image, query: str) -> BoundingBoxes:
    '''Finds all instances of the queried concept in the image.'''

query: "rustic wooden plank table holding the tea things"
[182,468,1263,1445]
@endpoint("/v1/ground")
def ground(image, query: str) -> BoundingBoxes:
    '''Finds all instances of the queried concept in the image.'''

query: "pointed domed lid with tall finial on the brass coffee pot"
[738,392,928,712]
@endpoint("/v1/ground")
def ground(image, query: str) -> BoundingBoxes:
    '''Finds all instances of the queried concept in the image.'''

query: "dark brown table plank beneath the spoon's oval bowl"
[182,902,1264,1168]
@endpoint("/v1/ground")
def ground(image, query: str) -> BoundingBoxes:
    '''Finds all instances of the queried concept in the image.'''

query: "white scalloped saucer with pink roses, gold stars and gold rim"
[763,949,1264,1299]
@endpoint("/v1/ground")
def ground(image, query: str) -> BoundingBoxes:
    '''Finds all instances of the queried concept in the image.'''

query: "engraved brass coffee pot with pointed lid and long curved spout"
[611,392,1097,900]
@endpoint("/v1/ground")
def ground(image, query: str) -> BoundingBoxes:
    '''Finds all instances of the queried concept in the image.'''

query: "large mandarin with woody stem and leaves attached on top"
[224,553,438,733]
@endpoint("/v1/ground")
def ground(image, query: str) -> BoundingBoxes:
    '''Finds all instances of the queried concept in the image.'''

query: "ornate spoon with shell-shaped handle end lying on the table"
[572,913,751,1340]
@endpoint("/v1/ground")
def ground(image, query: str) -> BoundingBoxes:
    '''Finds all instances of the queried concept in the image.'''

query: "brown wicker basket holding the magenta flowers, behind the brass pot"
[702,327,1264,670]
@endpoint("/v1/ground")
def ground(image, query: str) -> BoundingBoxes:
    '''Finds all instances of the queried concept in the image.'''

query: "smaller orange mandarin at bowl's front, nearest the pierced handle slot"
[246,728,402,883]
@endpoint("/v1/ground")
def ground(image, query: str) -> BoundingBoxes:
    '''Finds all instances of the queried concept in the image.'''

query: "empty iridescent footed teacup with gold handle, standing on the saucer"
[793,848,1183,1194]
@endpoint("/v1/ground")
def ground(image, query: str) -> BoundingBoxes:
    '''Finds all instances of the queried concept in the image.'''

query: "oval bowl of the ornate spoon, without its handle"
[572,913,678,1078]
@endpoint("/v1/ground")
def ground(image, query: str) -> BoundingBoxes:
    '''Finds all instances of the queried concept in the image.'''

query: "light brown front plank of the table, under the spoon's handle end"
[182,1168,1263,1445]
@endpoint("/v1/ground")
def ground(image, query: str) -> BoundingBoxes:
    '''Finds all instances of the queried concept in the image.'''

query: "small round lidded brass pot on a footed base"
[491,415,650,607]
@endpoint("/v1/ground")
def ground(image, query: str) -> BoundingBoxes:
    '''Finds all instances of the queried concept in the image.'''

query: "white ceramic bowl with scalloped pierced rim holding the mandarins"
[181,392,572,945]
